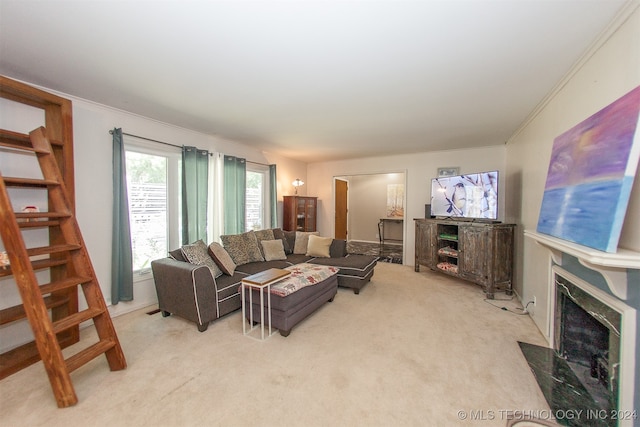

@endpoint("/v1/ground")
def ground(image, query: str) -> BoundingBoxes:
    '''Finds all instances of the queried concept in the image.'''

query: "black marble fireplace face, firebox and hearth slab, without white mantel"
[520,266,635,426]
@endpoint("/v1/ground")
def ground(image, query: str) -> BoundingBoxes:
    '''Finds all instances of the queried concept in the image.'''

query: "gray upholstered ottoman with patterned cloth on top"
[244,263,338,337]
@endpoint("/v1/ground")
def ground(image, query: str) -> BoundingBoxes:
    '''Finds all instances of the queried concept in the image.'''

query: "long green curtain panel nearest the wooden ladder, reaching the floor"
[111,129,133,305]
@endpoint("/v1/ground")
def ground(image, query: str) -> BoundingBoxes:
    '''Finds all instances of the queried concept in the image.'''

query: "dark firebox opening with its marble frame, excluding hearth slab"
[555,275,621,410]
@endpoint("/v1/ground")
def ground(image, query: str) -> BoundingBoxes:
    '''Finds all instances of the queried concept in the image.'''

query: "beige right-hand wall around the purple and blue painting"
[506,3,640,338]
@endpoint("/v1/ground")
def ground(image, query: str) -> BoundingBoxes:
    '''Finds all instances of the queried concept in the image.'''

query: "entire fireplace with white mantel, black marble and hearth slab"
[520,230,640,426]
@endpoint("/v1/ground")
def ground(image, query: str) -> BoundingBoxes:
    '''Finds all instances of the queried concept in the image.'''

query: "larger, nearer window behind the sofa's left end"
[125,141,180,273]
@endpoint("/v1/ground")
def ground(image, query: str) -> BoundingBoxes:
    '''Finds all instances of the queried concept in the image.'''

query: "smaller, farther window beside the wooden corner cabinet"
[245,166,270,231]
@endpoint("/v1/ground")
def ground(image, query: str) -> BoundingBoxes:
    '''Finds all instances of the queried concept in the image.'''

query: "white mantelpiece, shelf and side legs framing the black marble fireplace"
[525,231,640,425]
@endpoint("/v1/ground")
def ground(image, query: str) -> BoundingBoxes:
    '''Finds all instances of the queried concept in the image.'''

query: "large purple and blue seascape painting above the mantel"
[537,86,640,252]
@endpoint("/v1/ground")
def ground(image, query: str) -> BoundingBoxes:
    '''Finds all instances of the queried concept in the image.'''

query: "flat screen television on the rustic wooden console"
[431,171,498,220]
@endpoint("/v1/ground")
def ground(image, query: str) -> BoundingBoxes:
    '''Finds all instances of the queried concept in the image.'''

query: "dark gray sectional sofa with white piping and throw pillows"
[151,228,377,333]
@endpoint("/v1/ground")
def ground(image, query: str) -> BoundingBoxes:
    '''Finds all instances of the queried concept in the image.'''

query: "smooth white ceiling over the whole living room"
[0,0,626,162]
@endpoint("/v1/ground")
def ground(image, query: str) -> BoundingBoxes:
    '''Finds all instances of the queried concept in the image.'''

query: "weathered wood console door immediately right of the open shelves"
[458,225,491,285]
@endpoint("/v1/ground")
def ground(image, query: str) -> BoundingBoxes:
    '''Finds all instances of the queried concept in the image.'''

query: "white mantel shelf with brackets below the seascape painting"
[524,230,640,300]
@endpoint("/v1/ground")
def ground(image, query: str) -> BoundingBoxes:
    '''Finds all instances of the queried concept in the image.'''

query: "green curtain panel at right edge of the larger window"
[182,147,209,245]
